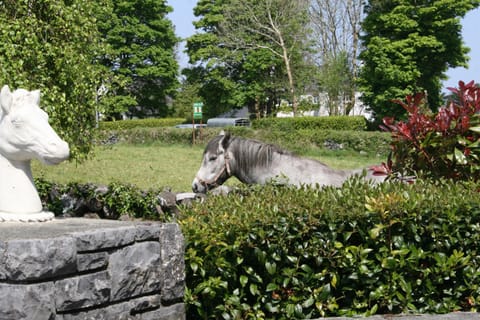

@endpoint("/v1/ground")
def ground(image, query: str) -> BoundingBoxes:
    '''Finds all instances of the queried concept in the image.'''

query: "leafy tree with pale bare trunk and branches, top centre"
[221,0,309,114]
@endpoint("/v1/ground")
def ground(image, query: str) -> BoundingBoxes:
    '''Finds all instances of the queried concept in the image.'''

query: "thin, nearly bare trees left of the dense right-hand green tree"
[310,0,364,114]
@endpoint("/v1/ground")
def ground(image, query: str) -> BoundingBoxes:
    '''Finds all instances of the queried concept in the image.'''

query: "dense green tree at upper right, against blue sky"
[360,0,480,122]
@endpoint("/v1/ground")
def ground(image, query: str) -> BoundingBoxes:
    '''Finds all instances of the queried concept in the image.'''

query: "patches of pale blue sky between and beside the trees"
[168,0,480,88]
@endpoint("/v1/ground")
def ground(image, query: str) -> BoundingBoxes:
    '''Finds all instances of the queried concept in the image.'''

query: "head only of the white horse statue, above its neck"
[0,85,70,164]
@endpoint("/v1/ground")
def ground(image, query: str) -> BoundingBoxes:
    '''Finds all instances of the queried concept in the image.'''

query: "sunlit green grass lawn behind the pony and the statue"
[32,144,384,192]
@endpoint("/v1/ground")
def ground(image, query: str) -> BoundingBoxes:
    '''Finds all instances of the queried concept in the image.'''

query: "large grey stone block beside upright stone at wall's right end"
[108,241,164,301]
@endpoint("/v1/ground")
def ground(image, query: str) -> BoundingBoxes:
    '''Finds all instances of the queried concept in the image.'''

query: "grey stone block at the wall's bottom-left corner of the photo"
[0,282,55,320]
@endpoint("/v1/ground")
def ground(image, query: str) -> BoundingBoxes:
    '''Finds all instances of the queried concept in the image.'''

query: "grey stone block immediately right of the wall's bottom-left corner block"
[55,271,111,312]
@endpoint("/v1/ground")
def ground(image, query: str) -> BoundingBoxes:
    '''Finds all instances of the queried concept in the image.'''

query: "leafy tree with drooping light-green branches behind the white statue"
[0,0,106,159]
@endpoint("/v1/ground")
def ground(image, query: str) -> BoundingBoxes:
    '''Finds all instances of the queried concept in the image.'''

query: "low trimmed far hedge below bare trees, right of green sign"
[252,116,367,132]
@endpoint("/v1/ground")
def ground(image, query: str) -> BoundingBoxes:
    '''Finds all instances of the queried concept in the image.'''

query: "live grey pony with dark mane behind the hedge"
[192,133,387,193]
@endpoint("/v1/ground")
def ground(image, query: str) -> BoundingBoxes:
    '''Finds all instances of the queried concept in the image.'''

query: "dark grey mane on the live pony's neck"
[229,137,295,170]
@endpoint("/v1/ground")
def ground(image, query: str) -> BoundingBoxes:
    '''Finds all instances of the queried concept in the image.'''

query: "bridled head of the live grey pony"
[192,131,232,193]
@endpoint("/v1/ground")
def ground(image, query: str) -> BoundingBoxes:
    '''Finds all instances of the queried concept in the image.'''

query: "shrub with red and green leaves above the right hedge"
[378,81,480,181]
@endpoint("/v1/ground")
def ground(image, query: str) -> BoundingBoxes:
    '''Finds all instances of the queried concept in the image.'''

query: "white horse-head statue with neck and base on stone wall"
[0,85,70,222]
